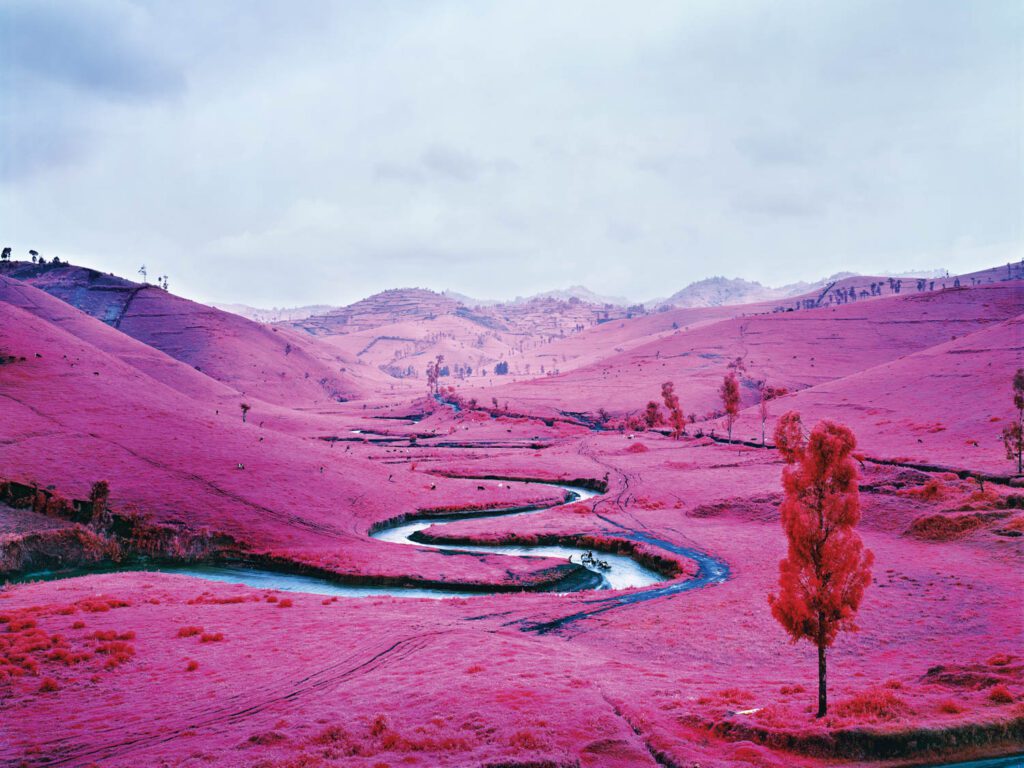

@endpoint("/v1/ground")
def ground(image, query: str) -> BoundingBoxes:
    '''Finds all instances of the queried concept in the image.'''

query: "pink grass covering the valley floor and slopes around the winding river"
[0,265,1024,768]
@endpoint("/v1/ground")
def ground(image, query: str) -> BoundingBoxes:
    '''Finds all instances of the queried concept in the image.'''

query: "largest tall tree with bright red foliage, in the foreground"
[768,411,874,718]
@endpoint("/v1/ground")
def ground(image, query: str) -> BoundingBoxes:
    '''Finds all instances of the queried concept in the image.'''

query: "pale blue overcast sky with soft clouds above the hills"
[0,0,1024,306]
